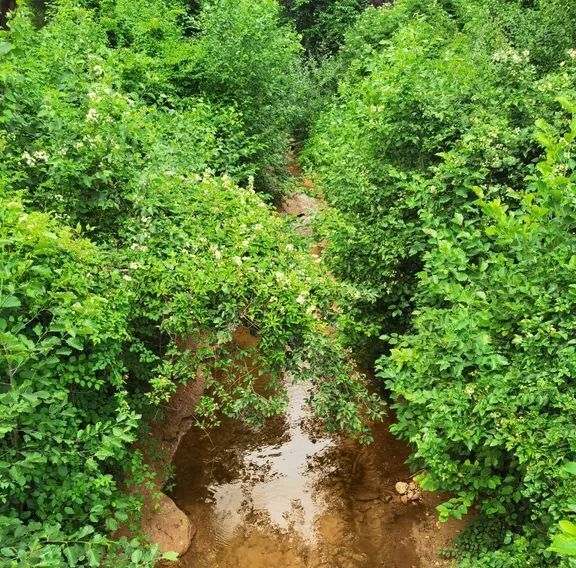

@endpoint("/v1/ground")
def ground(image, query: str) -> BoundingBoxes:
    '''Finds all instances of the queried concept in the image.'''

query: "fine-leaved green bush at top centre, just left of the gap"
[188,0,310,182]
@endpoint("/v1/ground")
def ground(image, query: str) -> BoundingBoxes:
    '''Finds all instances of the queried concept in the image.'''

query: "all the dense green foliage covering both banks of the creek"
[0,0,576,568]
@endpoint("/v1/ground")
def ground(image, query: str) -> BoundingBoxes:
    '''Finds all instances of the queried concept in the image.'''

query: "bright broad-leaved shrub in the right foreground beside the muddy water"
[379,111,576,566]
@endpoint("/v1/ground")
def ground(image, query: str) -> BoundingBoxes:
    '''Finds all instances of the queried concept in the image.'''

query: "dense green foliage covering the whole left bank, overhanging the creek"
[0,0,379,566]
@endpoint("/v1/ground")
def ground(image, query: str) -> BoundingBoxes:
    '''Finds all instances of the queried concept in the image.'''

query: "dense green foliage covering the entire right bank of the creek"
[306,0,576,567]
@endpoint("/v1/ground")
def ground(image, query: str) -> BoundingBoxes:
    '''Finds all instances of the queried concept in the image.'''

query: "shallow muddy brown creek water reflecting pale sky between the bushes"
[171,164,459,568]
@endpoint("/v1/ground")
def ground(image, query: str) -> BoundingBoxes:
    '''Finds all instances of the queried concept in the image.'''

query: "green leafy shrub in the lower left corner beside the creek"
[0,195,155,566]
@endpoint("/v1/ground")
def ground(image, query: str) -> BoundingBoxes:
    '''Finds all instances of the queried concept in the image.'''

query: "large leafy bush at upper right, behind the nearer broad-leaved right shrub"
[305,0,573,350]
